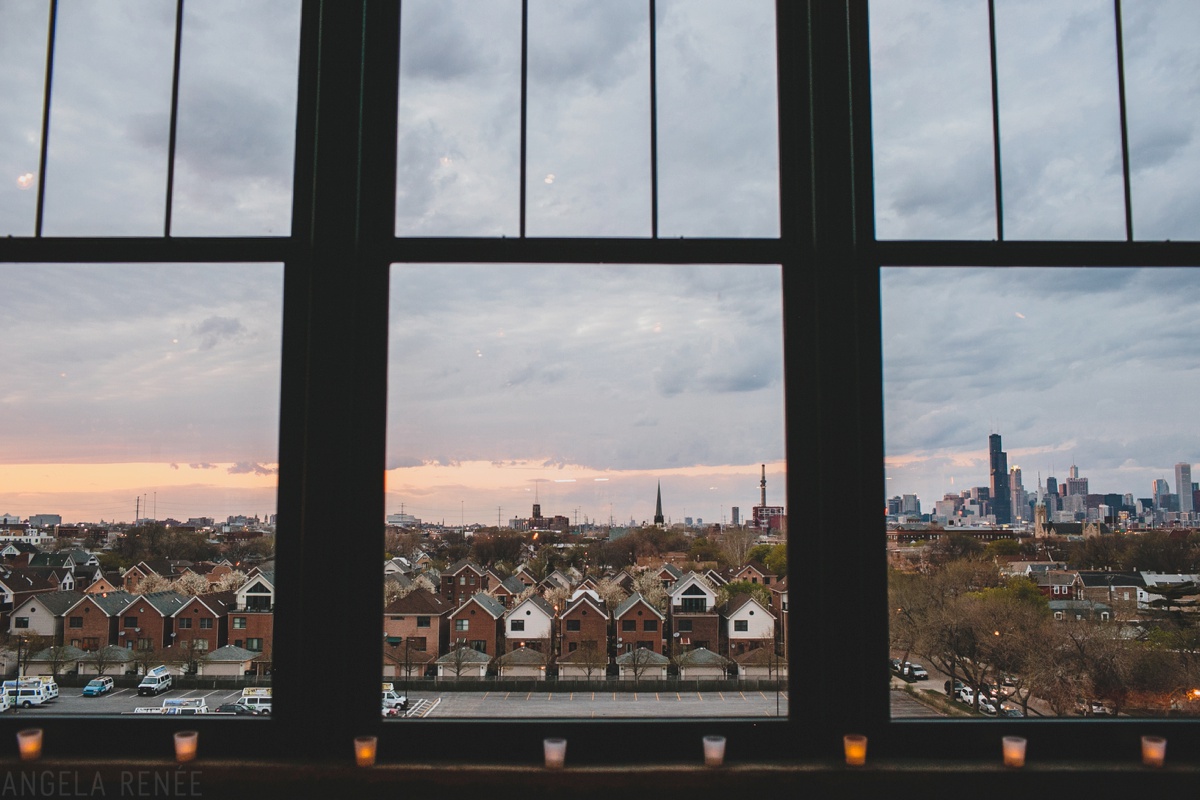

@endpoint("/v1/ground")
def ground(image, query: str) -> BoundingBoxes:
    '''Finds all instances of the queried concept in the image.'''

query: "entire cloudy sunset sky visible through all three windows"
[0,0,1200,524]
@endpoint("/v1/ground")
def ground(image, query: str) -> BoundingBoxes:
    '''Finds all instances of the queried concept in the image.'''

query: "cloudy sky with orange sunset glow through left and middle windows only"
[0,0,786,523]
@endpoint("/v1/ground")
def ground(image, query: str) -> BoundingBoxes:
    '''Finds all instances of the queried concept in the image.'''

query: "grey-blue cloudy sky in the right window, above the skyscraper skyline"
[872,0,1200,509]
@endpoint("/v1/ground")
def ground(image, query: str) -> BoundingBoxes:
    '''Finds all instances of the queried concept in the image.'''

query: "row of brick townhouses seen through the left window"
[8,570,275,671]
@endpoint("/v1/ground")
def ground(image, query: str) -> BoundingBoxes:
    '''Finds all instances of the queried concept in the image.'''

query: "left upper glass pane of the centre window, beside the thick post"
[396,0,521,236]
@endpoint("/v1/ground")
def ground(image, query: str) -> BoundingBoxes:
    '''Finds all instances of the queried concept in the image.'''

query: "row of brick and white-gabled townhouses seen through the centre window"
[384,563,787,676]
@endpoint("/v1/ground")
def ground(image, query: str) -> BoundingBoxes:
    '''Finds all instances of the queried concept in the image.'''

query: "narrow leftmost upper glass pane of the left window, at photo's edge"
[0,2,49,236]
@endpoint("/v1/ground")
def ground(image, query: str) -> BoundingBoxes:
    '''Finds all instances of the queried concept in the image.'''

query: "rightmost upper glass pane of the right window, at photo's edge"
[1121,0,1200,240]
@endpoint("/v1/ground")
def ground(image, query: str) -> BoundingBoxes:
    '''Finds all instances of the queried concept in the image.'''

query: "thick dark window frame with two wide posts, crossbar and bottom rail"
[0,0,1180,763]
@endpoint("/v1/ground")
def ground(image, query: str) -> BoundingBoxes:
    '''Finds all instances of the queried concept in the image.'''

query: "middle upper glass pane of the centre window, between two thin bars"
[524,0,650,236]
